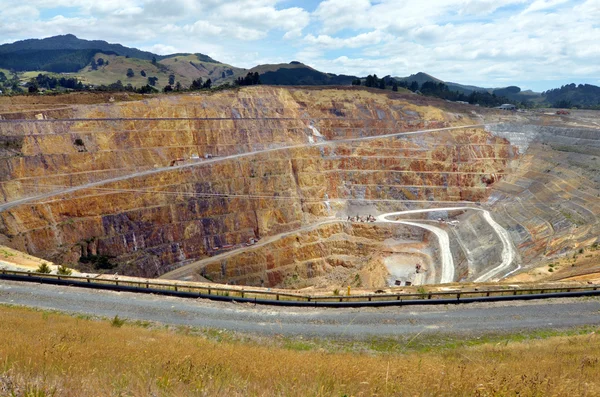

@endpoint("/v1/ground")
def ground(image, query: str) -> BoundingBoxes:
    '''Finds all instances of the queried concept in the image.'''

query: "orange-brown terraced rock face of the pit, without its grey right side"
[0,87,517,285]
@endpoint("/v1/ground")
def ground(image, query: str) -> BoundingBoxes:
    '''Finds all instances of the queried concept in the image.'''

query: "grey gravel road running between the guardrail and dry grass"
[0,280,600,339]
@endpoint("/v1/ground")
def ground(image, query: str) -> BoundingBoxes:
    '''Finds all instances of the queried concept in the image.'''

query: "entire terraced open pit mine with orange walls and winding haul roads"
[0,86,600,290]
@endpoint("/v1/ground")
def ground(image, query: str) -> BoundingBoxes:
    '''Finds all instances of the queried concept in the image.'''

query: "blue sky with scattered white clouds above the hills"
[0,0,600,91]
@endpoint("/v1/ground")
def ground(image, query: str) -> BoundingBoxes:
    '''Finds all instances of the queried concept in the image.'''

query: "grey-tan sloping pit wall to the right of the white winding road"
[488,124,600,267]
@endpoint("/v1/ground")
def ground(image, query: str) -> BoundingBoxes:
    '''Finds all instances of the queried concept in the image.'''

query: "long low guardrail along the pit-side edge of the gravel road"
[0,270,600,307]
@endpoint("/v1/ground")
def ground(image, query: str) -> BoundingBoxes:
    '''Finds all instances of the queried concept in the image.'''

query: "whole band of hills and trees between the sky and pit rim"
[0,34,600,108]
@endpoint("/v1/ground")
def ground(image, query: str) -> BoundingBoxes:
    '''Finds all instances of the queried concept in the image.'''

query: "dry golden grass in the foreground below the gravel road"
[0,306,600,397]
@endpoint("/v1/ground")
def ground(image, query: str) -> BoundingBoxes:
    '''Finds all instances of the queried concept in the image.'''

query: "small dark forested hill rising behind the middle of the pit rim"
[247,61,356,85]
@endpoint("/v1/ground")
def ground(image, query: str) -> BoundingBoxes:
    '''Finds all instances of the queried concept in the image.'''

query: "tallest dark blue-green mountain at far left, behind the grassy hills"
[0,34,219,73]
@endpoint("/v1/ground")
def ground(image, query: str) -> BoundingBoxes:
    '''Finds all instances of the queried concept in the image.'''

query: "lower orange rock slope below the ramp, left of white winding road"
[191,222,423,288]
